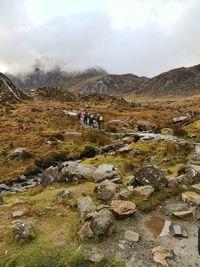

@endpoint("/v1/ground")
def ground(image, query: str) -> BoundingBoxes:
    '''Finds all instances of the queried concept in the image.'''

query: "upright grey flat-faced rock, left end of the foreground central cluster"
[77,196,96,221]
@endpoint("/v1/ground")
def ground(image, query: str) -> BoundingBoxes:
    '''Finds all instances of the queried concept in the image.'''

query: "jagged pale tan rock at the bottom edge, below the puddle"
[152,246,174,267]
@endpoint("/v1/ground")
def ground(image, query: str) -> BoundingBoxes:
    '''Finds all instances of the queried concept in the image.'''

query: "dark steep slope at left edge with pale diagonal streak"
[0,73,26,103]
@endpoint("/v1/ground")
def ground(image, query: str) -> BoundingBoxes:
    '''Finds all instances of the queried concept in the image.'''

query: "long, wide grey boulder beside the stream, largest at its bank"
[56,161,95,183]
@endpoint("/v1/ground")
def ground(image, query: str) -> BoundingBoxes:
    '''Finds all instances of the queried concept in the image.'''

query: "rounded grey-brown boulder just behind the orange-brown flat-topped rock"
[95,180,117,200]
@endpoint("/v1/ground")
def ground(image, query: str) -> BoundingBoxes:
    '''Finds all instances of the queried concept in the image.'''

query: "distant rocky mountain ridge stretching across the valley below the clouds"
[9,65,200,96]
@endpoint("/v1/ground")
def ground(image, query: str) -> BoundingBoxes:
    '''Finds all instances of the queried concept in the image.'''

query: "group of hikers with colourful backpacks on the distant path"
[77,111,104,130]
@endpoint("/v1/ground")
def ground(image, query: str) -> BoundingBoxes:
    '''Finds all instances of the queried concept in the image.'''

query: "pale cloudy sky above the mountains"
[0,0,200,77]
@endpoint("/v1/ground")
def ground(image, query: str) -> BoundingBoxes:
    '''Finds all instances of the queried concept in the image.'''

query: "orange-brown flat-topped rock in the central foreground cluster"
[111,200,136,218]
